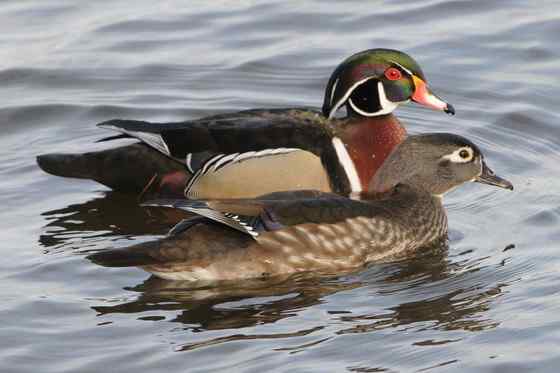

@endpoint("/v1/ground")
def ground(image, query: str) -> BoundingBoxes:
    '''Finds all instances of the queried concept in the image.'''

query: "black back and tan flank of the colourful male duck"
[95,109,349,195]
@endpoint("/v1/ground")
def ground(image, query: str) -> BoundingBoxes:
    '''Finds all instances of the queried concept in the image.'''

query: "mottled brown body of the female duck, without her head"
[96,186,447,281]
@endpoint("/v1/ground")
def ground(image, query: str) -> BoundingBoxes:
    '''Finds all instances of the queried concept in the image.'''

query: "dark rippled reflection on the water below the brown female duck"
[92,244,511,350]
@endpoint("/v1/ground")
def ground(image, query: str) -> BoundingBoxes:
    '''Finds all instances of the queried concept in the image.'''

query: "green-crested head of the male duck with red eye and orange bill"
[323,49,455,118]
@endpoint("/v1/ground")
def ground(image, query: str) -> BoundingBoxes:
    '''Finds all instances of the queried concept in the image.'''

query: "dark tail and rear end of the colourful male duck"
[37,143,188,197]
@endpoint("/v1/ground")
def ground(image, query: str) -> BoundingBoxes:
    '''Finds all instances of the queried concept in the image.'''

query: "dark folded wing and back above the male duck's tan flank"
[98,109,334,165]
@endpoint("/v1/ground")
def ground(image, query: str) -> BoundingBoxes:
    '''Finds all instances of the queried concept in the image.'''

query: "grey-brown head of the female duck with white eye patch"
[369,133,513,195]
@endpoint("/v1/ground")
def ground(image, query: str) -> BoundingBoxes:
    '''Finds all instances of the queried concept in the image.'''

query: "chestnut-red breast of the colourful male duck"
[340,114,406,192]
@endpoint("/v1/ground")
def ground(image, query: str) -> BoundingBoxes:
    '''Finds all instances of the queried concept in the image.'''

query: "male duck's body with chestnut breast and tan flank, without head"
[39,109,406,199]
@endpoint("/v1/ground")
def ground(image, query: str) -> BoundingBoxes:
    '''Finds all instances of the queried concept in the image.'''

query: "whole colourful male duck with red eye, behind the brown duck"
[37,49,455,199]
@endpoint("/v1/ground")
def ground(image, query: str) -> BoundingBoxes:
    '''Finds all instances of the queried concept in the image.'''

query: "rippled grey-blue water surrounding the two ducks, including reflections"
[0,0,560,372]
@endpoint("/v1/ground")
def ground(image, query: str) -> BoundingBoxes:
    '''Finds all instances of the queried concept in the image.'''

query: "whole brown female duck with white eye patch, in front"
[88,133,513,281]
